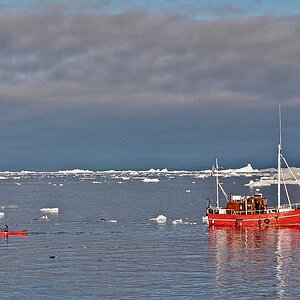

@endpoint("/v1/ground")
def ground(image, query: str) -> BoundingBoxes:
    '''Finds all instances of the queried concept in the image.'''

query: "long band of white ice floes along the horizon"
[0,164,300,187]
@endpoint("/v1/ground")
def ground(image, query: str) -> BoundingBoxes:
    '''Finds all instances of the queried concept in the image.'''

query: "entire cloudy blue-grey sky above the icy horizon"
[0,0,300,171]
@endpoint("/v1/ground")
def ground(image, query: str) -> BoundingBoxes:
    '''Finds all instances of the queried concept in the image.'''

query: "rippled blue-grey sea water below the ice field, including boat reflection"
[0,173,300,299]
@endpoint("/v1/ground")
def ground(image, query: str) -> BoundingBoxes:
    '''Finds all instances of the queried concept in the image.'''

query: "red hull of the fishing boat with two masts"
[208,209,300,226]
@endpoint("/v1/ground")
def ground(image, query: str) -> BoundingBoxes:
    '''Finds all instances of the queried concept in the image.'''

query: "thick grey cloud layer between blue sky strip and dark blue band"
[0,9,300,115]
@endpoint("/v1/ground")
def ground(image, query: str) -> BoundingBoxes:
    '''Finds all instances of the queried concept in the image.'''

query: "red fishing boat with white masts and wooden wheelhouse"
[203,107,300,226]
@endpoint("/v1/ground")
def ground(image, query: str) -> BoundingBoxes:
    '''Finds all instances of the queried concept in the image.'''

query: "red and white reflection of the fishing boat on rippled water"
[208,226,300,299]
